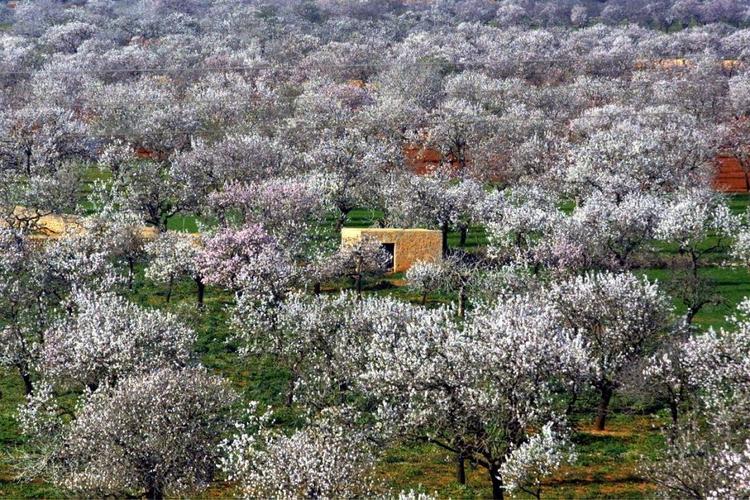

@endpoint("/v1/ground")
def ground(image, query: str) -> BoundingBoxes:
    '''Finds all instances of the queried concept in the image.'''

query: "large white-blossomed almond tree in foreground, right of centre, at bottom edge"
[359,297,587,498]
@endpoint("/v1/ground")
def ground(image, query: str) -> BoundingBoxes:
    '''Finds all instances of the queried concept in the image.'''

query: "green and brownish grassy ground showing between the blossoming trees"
[0,196,750,498]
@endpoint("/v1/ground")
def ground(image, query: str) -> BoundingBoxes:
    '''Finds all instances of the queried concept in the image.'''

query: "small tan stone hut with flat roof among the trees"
[341,227,443,273]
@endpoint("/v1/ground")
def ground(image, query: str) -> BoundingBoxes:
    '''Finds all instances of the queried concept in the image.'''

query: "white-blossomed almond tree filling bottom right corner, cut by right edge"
[644,301,750,498]
